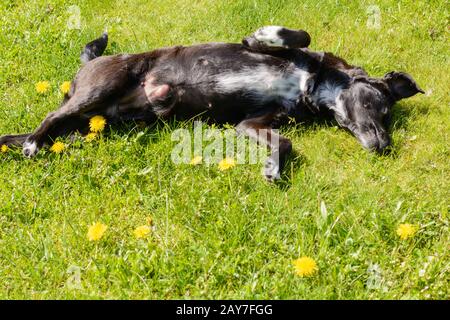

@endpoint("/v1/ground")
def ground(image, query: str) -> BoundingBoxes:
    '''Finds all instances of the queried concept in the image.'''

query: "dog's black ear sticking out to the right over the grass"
[383,71,425,101]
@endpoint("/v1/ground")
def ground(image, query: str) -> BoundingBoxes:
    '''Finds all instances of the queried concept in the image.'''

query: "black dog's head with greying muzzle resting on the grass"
[334,72,424,152]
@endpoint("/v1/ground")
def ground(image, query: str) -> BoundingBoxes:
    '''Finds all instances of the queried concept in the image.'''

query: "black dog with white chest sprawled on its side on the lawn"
[0,26,423,180]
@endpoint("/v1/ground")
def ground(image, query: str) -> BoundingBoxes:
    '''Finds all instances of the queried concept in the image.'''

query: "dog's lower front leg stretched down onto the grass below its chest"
[236,112,292,181]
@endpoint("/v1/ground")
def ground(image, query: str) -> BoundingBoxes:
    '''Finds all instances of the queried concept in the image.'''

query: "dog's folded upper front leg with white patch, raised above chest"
[242,26,311,53]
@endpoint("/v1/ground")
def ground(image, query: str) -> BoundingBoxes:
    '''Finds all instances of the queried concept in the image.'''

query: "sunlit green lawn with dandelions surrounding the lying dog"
[0,0,450,299]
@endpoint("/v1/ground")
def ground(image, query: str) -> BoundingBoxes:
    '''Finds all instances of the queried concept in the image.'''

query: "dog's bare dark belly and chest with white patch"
[126,44,310,122]
